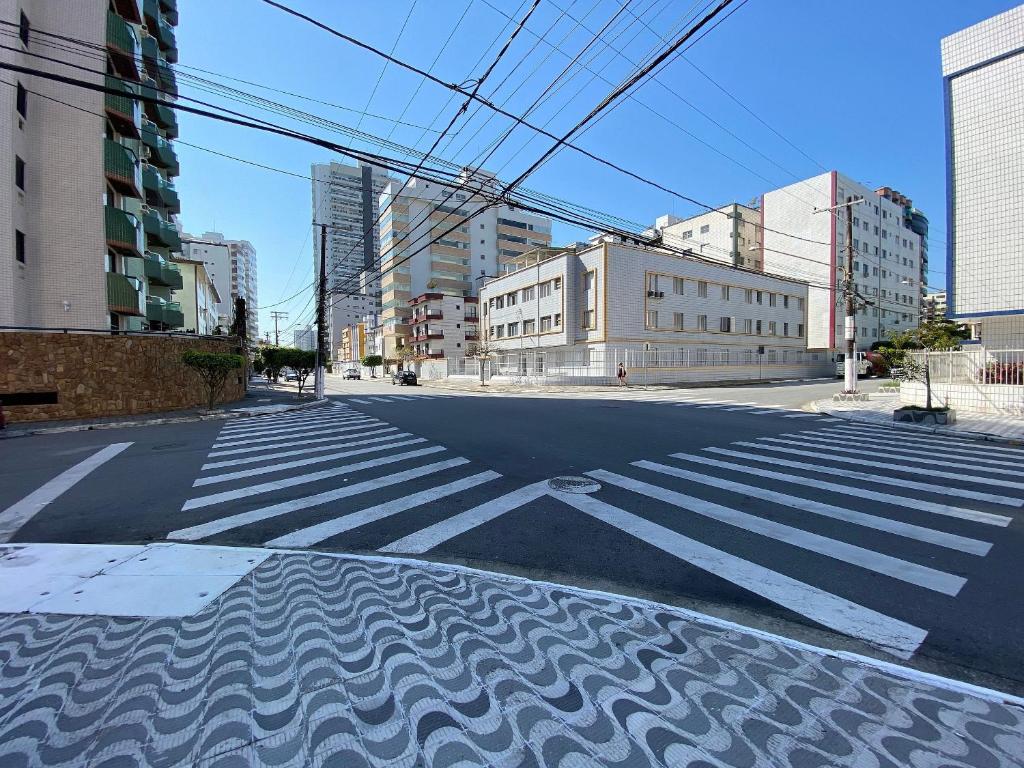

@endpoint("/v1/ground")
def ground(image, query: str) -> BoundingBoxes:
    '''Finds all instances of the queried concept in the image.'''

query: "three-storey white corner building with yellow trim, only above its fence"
[480,243,808,359]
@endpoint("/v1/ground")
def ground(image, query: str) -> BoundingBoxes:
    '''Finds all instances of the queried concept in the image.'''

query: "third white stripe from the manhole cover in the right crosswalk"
[633,461,992,556]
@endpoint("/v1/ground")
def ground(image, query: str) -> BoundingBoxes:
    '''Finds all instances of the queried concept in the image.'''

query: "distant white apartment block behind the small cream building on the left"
[181,232,259,343]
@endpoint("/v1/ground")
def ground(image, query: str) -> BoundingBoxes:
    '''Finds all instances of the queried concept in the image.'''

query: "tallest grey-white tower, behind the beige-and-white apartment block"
[310,163,390,356]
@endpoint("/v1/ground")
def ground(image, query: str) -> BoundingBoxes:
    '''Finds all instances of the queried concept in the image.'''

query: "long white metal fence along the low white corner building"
[447,347,831,386]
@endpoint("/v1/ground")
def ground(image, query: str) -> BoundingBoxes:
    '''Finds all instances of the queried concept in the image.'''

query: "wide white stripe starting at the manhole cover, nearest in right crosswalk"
[552,494,928,658]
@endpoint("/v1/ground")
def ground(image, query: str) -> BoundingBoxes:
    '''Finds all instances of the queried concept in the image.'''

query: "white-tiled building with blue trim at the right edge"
[942,5,1024,349]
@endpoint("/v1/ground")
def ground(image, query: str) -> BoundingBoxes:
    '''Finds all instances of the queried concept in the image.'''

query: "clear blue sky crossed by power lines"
[177,0,1018,343]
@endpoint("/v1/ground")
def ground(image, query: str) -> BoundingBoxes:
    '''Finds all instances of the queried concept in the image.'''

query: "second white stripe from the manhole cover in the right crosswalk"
[587,469,967,595]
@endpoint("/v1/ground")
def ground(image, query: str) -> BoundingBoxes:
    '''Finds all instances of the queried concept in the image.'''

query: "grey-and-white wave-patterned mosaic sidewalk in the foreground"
[0,545,1024,768]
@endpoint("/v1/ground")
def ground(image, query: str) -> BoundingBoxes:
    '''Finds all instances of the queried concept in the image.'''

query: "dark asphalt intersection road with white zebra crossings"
[0,381,1024,693]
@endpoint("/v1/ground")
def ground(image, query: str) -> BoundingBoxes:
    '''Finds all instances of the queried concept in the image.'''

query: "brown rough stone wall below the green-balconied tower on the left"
[0,332,245,422]
